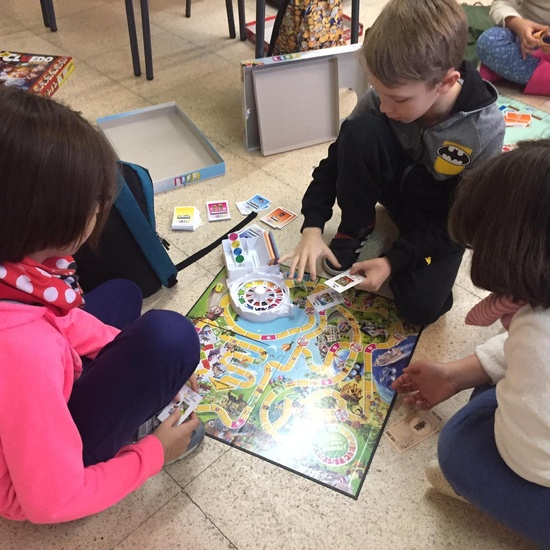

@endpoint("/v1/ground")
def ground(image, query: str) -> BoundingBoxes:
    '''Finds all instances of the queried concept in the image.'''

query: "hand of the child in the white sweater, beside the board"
[392,360,460,411]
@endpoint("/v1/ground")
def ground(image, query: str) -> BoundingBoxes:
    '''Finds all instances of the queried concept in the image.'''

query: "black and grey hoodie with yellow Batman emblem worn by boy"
[302,61,505,272]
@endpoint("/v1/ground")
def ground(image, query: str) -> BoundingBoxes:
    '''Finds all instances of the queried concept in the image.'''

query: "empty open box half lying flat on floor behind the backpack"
[97,101,225,193]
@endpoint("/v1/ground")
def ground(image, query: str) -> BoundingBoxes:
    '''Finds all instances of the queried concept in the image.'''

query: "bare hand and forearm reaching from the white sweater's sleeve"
[392,354,492,410]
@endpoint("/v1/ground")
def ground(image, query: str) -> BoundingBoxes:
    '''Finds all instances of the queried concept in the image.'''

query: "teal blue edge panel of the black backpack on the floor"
[115,165,178,288]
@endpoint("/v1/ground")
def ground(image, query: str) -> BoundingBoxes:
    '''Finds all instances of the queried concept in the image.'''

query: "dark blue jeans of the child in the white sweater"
[438,386,550,548]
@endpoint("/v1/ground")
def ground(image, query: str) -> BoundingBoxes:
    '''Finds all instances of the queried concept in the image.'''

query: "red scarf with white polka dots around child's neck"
[0,256,84,315]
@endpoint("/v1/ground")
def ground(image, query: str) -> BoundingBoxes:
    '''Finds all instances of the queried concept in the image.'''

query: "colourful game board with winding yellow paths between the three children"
[188,269,420,498]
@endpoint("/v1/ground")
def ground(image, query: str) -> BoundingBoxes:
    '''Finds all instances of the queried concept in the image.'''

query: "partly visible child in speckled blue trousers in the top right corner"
[477,0,550,95]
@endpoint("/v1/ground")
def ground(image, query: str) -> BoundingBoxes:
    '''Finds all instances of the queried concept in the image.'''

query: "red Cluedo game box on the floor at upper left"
[0,50,74,97]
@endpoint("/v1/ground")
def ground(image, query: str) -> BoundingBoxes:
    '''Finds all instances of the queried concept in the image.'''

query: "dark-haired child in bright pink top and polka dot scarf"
[0,87,204,523]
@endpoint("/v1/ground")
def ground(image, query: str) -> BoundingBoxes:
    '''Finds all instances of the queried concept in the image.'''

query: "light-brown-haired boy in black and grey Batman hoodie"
[281,0,505,325]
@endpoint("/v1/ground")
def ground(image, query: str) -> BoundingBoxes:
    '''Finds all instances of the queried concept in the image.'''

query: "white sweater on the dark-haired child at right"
[475,305,550,487]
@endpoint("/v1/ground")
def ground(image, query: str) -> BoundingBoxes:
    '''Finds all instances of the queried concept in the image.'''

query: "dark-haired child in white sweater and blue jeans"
[393,140,550,548]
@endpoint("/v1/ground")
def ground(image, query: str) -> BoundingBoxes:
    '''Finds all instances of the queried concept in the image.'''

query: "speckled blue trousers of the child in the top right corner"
[476,27,540,86]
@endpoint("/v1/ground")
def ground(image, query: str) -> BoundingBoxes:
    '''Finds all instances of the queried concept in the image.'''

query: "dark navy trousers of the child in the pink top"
[68,279,200,466]
